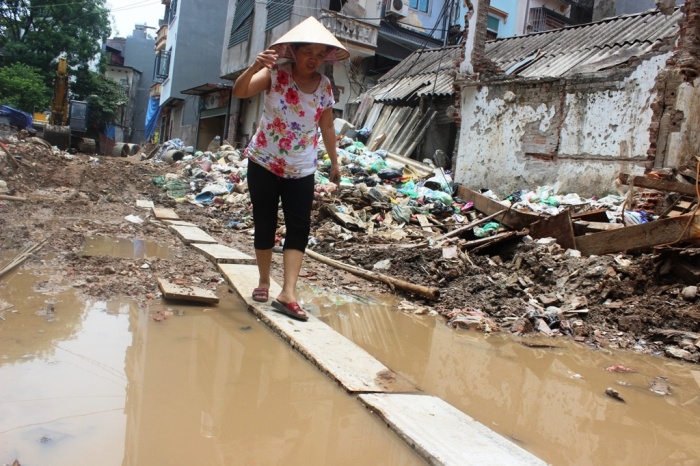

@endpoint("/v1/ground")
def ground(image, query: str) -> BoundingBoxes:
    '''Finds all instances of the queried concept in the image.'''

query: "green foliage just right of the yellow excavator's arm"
[71,66,127,132]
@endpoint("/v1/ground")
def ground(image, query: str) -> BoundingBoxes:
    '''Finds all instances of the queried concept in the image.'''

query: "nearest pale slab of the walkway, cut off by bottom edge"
[358,393,547,466]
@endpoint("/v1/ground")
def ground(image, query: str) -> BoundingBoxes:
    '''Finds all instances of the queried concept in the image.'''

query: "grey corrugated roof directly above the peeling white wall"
[485,9,683,77]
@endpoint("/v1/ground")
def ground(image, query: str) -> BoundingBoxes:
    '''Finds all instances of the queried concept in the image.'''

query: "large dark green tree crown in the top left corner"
[0,0,111,85]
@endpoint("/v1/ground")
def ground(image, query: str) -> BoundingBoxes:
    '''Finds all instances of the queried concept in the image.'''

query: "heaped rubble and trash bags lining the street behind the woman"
[0,126,700,362]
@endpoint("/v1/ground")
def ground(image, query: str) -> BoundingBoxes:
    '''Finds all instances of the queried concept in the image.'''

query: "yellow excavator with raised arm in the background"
[44,57,96,154]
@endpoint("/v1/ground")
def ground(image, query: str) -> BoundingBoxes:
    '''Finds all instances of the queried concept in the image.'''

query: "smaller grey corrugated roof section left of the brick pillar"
[367,45,461,102]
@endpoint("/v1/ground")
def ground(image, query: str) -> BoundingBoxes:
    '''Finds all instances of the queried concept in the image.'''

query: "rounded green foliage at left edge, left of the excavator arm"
[0,63,51,113]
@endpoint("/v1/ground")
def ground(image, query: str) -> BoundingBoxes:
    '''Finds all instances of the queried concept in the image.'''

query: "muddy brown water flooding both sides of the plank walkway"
[0,241,700,466]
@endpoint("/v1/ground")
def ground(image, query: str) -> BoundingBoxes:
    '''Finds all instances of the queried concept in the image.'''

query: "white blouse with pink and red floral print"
[245,63,335,178]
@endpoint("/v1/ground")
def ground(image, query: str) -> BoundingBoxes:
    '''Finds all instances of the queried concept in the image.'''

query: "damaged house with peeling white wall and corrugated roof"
[453,9,699,196]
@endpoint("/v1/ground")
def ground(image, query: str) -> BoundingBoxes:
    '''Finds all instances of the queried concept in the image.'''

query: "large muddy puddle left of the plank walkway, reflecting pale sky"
[0,273,424,466]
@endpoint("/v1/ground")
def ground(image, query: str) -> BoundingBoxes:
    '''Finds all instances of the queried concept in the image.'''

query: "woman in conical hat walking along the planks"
[233,17,349,321]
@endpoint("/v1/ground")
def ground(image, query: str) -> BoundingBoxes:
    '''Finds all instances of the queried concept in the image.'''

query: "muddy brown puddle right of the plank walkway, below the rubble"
[303,289,700,465]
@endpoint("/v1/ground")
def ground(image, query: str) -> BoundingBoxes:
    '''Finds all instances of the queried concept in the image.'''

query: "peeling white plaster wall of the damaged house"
[454,54,670,196]
